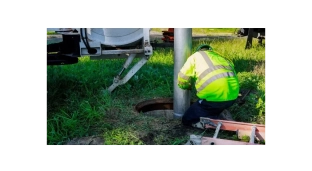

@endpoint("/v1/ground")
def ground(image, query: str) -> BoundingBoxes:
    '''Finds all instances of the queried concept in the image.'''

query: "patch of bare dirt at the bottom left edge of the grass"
[64,136,104,146]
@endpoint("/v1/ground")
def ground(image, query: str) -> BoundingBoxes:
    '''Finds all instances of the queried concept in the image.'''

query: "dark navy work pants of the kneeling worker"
[182,100,235,126]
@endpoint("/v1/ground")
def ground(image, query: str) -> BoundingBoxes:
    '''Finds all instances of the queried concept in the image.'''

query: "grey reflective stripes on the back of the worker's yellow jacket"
[196,51,235,92]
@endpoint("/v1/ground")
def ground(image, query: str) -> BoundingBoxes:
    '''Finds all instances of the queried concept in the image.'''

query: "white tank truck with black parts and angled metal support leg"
[46,28,153,92]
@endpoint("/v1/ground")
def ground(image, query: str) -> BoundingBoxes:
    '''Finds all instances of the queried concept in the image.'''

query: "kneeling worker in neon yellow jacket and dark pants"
[178,45,239,126]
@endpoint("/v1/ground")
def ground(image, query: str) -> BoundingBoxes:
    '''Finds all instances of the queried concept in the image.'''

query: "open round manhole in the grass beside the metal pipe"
[135,98,193,119]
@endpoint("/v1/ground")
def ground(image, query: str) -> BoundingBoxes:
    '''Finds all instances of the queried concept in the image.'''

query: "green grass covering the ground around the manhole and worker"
[46,30,266,146]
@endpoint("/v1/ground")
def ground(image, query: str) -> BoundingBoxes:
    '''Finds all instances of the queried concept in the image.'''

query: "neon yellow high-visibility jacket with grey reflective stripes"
[178,50,239,102]
